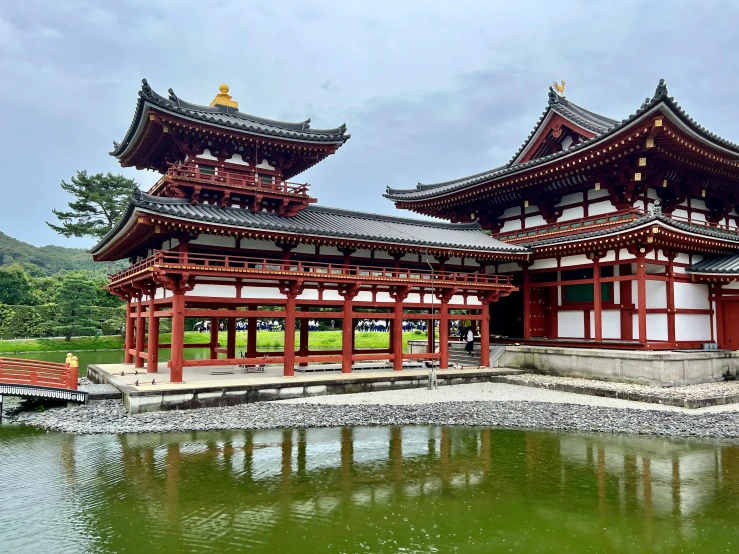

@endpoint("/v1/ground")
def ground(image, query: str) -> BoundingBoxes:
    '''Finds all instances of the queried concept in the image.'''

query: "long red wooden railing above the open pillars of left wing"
[110,250,511,286]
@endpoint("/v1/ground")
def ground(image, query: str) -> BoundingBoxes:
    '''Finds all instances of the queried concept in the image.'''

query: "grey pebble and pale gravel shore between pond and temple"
[10,383,739,438]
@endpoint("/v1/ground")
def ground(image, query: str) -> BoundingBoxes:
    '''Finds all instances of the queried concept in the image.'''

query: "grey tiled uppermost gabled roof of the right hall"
[384,79,739,202]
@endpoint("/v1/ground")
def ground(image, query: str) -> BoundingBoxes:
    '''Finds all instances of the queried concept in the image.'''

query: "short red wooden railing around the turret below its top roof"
[157,164,310,197]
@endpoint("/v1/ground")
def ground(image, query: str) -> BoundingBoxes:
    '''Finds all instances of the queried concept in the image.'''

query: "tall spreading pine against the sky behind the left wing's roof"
[46,171,137,239]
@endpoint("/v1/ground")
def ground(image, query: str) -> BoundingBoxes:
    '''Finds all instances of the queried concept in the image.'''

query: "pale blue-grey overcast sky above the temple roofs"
[0,0,739,247]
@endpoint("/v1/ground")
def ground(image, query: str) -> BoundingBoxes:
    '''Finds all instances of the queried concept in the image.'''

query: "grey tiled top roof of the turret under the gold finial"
[110,79,351,157]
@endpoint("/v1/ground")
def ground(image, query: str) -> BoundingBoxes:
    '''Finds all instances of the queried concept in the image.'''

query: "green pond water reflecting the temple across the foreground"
[0,424,739,553]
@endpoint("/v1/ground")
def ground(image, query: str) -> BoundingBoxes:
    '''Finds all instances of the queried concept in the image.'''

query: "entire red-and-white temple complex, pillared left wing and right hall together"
[93,80,739,383]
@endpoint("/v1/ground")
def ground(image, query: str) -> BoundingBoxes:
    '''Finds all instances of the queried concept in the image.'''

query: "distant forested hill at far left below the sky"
[0,233,115,275]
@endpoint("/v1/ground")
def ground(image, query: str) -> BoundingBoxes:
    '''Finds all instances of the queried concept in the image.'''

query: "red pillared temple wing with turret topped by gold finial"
[92,80,530,383]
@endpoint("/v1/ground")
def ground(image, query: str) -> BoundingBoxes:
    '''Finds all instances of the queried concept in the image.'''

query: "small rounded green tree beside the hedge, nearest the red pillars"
[54,271,98,340]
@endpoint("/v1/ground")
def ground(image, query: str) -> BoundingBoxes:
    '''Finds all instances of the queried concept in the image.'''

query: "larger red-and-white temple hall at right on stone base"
[385,80,739,350]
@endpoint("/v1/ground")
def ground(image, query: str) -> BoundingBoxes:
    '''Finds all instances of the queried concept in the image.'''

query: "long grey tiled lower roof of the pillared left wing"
[92,193,528,253]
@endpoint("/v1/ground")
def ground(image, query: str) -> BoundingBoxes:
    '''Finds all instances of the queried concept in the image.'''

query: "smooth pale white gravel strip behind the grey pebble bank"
[273,382,739,414]
